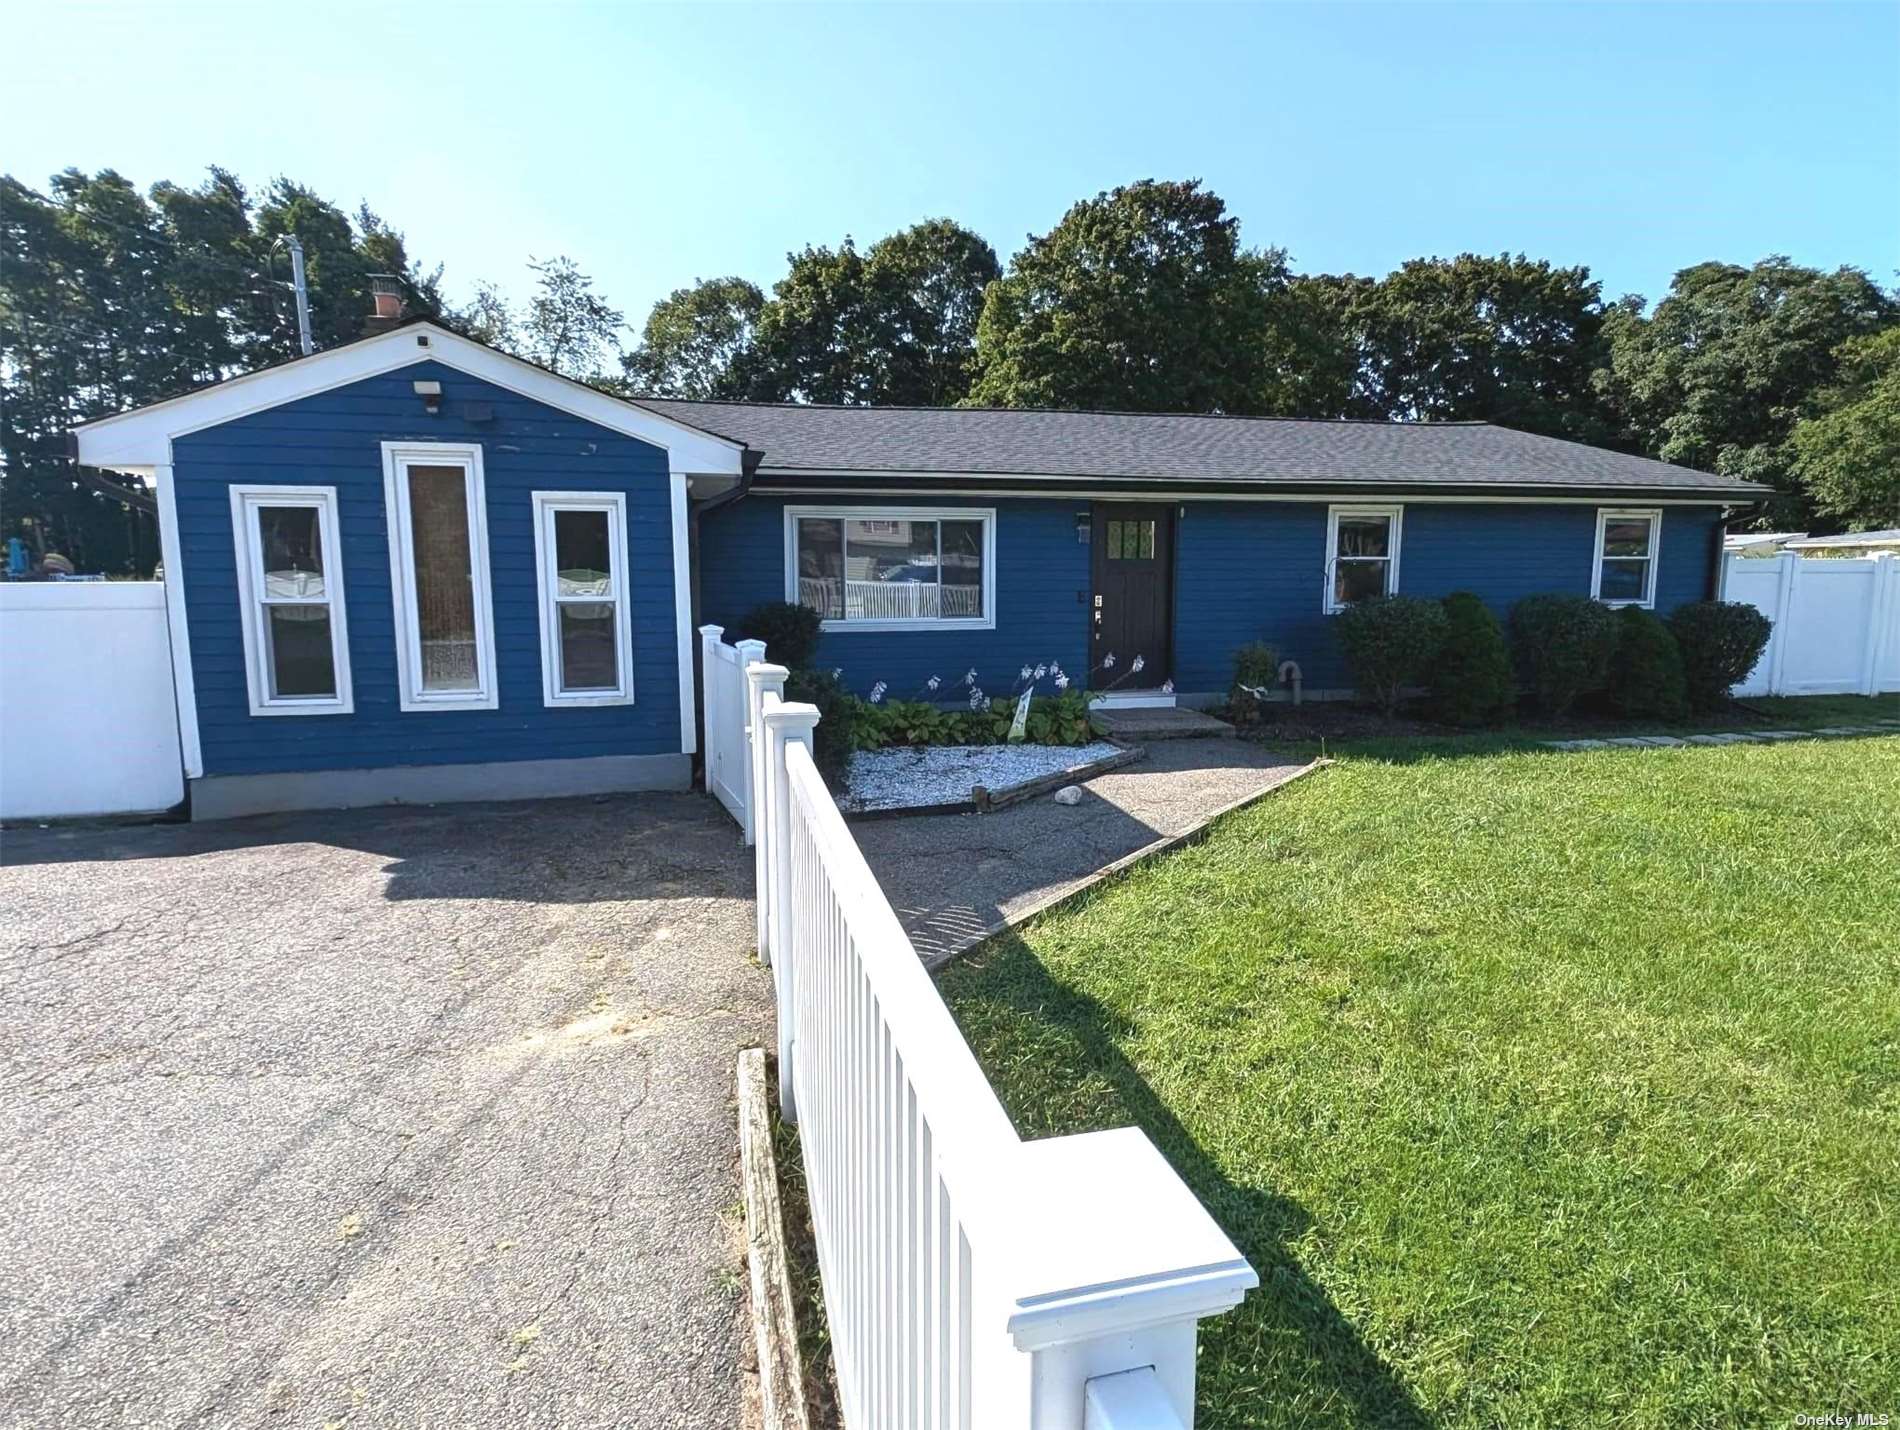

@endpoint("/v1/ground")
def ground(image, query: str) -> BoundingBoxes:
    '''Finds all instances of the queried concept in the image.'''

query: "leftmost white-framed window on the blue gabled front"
[230,486,355,716]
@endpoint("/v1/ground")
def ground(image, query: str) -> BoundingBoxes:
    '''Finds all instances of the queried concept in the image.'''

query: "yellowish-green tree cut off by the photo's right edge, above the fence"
[1790,325,1900,530]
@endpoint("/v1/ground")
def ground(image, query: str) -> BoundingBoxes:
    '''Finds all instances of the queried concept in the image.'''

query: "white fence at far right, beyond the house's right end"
[1721,551,1900,697]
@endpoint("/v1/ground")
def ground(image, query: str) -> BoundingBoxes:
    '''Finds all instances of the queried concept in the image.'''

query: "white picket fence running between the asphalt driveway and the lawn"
[707,638,1260,1430]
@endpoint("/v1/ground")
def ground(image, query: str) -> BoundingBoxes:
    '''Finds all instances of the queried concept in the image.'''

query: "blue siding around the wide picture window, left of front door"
[699,496,1089,699]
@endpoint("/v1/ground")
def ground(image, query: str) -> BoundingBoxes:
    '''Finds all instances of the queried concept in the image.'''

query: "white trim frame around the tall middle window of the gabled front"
[382,442,498,710]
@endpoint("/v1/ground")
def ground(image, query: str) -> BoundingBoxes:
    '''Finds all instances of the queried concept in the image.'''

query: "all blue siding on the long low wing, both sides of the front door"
[699,496,1720,695]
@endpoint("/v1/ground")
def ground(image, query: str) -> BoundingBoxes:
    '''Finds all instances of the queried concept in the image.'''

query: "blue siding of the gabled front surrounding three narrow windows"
[173,363,680,775]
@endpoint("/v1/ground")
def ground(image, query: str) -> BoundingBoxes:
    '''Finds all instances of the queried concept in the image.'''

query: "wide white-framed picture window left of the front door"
[785,507,996,630]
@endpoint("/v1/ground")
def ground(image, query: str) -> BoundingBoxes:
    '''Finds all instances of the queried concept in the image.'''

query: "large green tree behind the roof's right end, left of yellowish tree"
[1598,256,1900,526]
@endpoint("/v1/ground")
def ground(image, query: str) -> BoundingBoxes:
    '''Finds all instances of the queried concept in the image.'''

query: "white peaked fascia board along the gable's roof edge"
[74,323,745,477]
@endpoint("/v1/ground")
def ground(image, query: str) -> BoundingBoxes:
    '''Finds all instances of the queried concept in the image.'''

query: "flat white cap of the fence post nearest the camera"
[1007,1128,1260,1350]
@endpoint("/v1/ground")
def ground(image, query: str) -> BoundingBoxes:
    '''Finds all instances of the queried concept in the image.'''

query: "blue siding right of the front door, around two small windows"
[1174,501,1721,693]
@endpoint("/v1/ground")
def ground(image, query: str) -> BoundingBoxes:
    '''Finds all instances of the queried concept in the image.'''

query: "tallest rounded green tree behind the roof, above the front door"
[967,179,1284,412]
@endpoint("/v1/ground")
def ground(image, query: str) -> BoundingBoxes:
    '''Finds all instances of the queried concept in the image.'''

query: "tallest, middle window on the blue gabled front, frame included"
[382,442,496,710]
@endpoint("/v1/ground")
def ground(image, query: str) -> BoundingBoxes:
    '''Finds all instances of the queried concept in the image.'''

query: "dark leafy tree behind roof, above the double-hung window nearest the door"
[1347,253,1609,441]
